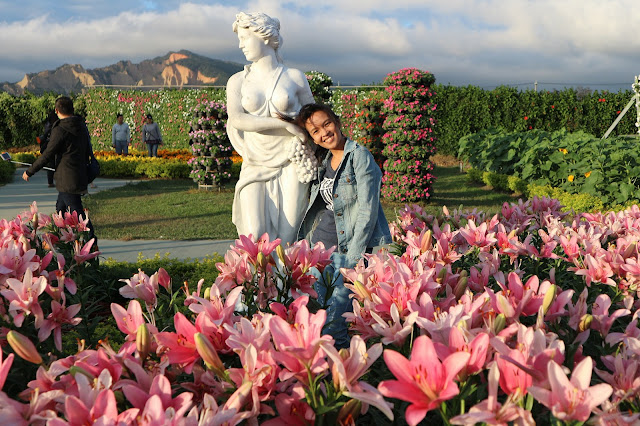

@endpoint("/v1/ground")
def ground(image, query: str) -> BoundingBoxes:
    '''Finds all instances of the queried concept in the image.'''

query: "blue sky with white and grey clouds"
[0,0,640,90]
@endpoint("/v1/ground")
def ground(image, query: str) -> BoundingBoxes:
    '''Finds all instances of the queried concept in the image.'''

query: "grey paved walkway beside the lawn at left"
[0,167,234,262]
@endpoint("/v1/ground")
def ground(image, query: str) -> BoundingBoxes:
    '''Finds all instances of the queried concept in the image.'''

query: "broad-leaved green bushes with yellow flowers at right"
[459,128,640,206]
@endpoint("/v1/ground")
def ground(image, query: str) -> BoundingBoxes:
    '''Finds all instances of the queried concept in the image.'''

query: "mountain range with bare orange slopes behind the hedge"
[0,50,244,95]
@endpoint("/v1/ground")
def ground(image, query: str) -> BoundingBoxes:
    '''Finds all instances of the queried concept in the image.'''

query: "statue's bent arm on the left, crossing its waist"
[227,73,289,132]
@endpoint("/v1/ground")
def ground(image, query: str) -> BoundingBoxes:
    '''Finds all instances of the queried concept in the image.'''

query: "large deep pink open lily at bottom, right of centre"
[378,336,470,425]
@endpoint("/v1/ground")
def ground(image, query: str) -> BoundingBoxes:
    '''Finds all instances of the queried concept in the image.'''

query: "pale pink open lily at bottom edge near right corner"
[529,357,613,422]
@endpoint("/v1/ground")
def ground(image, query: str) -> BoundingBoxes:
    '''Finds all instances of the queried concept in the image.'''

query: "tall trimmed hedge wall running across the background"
[0,79,637,155]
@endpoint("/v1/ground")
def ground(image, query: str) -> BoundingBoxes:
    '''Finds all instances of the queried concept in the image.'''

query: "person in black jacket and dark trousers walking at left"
[22,96,95,243]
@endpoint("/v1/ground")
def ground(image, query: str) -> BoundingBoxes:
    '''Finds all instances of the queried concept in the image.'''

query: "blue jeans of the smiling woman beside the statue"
[313,253,353,349]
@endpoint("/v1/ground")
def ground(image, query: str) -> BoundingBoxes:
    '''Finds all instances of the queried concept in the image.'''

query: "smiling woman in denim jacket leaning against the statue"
[295,104,391,348]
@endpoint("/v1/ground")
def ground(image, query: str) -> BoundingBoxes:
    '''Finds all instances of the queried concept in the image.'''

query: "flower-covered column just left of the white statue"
[189,99,233,189]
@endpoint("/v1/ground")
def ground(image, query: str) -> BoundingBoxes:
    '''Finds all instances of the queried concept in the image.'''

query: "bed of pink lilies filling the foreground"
[6,198,640,424]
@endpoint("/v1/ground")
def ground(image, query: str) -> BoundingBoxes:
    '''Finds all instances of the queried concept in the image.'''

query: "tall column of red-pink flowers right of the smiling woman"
[382,68,436,202]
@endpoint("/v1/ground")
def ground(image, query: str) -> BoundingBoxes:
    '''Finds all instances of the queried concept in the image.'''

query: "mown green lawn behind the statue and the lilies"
[85,166,513,240]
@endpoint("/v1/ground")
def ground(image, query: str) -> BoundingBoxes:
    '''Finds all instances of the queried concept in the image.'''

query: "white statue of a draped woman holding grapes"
[227,13,314,244]
